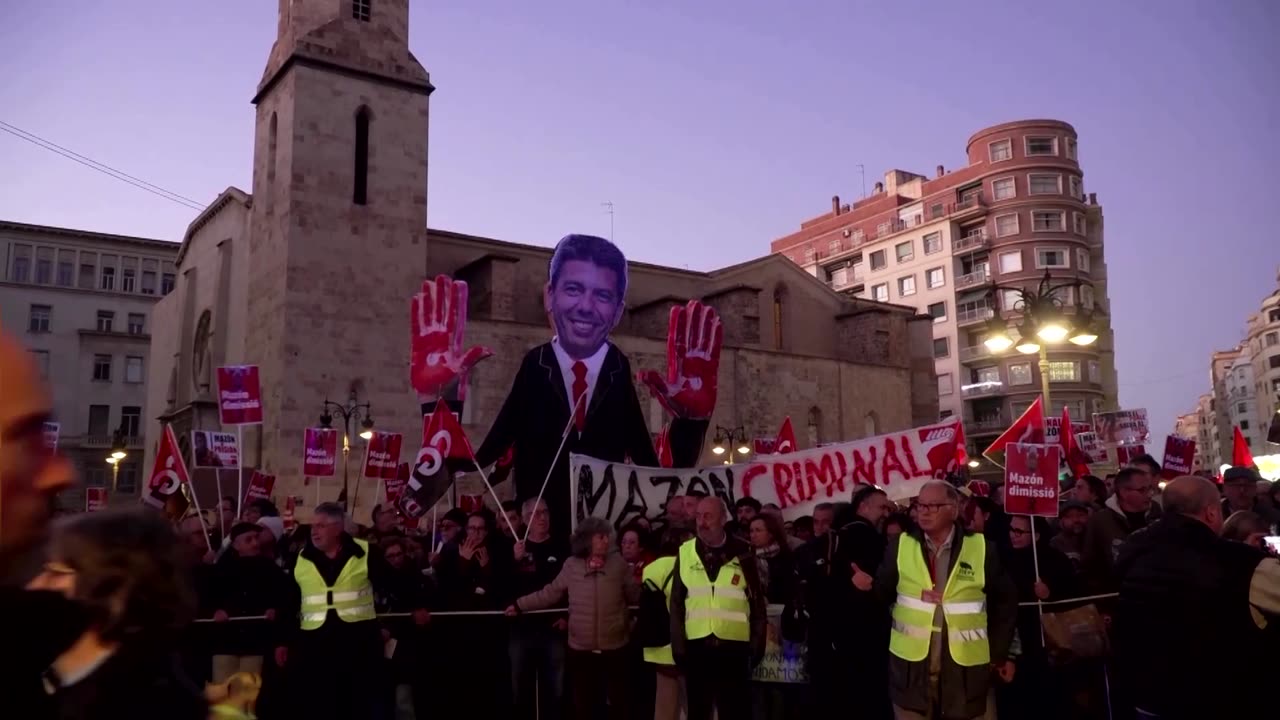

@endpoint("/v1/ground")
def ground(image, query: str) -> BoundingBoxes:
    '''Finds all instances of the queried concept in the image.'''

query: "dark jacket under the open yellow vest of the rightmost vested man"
[876,525,1018,720]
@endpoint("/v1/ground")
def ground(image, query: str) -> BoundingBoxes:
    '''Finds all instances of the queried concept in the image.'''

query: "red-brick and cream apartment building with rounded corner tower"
[772,119,1117,450]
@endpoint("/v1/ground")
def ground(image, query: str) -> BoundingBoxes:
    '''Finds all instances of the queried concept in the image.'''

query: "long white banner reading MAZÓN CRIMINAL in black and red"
[570,419,964,528]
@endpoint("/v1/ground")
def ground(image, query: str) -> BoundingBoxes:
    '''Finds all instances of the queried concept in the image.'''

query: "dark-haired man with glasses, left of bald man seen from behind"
[1080,466,1158,593]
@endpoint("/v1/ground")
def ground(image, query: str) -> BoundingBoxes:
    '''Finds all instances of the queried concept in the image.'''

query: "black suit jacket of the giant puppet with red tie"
[461,343,708,537]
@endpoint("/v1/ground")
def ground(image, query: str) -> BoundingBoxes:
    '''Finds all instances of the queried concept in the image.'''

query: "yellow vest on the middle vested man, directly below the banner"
[680,539,751,642]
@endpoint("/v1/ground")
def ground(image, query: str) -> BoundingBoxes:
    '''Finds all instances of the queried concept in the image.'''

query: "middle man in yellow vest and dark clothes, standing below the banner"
[671,497,768,720]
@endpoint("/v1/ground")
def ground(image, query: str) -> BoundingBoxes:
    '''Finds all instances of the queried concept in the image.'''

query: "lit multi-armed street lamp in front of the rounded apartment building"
[983,270,1098,410]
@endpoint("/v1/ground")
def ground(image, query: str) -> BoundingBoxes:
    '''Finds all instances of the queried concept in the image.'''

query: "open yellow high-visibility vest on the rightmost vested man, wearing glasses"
[888,533,991,667]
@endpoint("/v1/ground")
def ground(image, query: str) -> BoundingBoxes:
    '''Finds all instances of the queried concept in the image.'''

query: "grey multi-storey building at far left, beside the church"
[0,222,178,509]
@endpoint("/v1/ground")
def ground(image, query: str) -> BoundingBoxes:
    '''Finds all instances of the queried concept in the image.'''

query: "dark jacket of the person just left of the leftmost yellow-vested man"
[205,548,289,655]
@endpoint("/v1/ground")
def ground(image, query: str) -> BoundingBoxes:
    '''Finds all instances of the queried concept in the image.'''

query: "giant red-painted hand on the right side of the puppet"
[637,300,724,420]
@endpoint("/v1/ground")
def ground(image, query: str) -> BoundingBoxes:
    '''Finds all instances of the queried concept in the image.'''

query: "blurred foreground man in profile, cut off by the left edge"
[0,325,84,717]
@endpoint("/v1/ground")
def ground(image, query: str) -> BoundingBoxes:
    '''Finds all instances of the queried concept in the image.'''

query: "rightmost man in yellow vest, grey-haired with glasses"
[852,480,1018,720]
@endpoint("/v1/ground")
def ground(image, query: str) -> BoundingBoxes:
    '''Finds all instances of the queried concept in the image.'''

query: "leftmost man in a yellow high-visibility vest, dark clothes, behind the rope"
[275,502,426,720]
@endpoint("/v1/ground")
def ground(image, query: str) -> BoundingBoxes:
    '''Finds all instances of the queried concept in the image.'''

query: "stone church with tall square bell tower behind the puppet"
[145,0,938,518]
